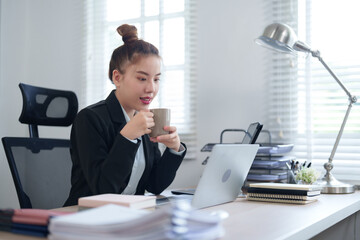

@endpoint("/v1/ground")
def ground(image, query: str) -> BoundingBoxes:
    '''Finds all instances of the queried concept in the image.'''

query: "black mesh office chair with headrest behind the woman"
[2,83,78,209]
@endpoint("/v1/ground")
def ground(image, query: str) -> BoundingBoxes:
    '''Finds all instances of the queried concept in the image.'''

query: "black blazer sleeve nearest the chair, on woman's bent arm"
[71,110,140,194]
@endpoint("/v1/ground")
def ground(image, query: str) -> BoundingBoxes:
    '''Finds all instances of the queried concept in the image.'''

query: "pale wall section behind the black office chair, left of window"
[0,0,82,208]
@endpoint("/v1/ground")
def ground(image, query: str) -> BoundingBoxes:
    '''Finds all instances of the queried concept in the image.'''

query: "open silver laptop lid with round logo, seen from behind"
[191,144,259,208]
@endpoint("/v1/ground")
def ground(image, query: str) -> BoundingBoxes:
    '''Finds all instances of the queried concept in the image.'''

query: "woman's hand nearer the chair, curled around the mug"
[120,109,155,140]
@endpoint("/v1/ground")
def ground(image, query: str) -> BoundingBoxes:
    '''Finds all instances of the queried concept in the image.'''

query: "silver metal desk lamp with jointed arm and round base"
[255,23,357,193]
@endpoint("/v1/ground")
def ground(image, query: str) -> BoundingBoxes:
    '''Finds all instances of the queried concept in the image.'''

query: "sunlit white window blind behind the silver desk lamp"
[264,0,360,183]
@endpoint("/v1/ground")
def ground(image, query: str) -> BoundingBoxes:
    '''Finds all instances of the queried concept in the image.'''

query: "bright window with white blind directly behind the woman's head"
[80,0,197,159]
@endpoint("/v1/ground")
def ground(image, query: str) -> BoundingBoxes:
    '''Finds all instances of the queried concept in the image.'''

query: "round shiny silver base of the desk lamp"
[318,176,355,194]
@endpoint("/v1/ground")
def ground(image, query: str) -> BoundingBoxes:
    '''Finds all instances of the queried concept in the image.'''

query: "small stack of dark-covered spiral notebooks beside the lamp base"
[246,183,321,204]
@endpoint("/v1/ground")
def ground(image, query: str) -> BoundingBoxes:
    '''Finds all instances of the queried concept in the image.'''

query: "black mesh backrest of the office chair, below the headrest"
[2,137,72,209]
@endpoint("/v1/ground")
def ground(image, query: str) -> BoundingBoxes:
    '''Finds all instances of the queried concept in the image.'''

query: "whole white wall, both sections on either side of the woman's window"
[0,0,264,208]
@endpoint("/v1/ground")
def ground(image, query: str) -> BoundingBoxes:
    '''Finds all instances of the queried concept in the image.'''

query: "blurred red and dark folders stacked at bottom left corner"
[0,209,70,237]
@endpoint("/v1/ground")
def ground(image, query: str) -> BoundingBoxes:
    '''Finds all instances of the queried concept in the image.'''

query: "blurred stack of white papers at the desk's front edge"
[49,202,224,240]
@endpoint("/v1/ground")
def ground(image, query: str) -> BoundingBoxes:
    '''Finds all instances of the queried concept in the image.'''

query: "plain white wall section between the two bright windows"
[172,0,265,187]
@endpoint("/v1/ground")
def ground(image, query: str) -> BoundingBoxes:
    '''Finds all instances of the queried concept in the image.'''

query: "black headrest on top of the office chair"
[19,83,78,126]
